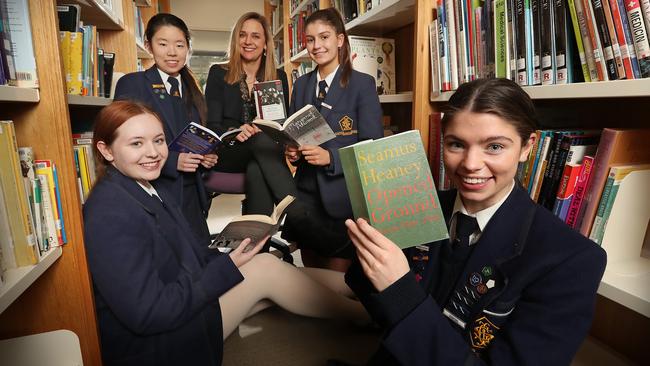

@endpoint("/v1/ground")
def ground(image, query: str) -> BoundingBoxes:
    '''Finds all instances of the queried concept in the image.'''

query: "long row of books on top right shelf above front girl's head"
[429,0,650,93]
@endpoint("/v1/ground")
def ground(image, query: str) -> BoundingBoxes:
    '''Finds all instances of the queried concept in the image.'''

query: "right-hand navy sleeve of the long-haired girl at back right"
[325,74,384,176]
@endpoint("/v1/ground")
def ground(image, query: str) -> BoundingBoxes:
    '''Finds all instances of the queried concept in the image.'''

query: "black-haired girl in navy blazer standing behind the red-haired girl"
[115,13,217,243]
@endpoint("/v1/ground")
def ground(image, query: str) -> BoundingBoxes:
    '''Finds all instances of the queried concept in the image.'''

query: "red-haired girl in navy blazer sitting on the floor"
[83,101,368,366]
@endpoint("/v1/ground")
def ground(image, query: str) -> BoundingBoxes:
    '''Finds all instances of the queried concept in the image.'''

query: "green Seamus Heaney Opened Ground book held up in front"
[339,131,449,248]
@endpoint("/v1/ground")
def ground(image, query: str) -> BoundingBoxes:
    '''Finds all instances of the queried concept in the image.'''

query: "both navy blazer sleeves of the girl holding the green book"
[346,240,605,366]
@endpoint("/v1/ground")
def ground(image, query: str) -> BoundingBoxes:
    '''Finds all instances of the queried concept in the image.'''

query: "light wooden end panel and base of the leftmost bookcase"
[0,0,101,365]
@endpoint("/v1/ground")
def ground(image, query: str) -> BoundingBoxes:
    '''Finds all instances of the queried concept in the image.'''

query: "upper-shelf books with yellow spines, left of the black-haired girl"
[57,4,116,97]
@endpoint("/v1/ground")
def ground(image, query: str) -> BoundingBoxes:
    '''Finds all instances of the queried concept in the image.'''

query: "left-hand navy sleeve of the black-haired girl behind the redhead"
[114,73,181,179]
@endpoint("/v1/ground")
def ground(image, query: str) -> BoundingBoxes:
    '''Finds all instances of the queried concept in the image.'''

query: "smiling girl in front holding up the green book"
[346,79,606,365]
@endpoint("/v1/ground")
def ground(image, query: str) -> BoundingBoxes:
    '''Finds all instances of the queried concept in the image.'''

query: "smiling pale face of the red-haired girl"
[97,113,168,186]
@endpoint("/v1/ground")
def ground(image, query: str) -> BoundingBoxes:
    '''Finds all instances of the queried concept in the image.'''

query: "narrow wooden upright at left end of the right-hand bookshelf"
[412,0,433,150]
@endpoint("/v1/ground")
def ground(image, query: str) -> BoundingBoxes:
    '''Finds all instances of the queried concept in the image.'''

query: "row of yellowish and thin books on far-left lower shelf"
[0,121,67,288]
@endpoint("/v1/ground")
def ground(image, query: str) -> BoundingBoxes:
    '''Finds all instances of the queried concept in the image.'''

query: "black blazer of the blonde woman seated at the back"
[205,65,289,134]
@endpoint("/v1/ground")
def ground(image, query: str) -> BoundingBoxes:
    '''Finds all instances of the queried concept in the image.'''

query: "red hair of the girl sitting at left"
[93,100,162,177]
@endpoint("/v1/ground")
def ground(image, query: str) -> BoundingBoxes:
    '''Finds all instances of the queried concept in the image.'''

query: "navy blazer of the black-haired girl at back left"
[115,65,209,211]
